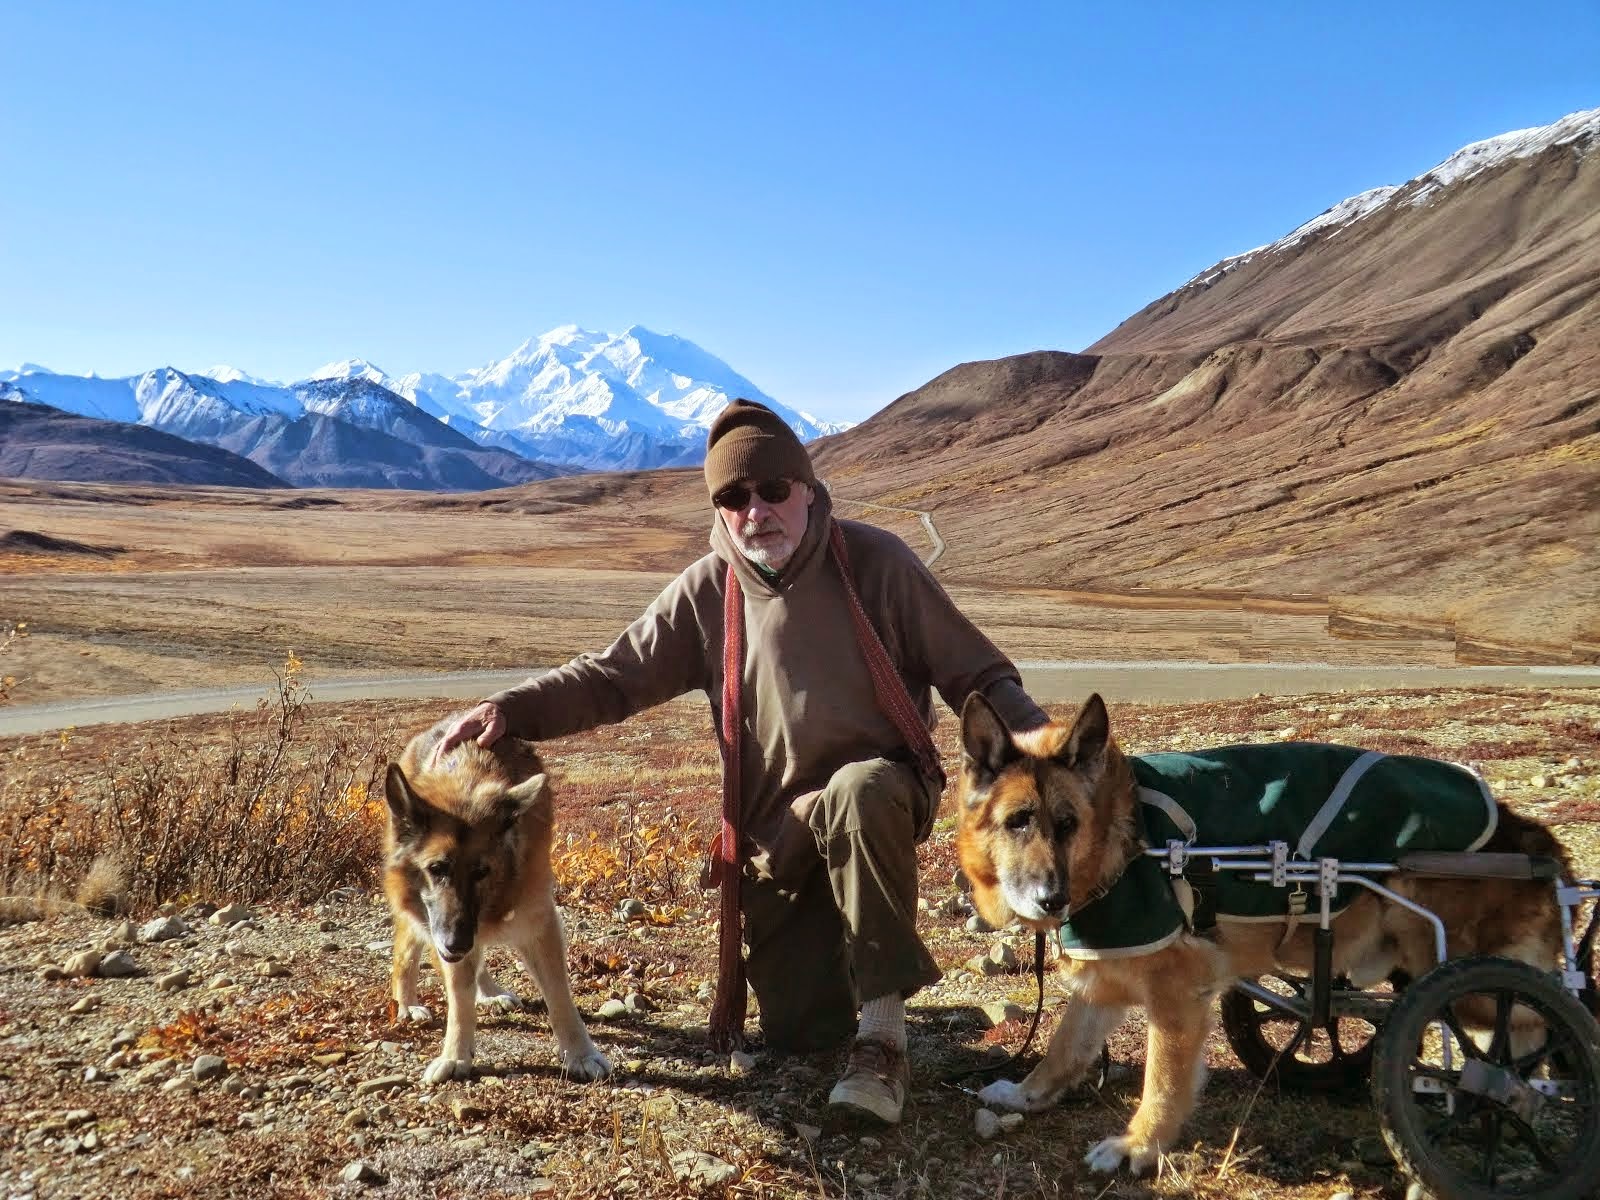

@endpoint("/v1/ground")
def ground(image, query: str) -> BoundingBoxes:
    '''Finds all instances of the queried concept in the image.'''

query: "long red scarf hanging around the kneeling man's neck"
[710,523,944,1051]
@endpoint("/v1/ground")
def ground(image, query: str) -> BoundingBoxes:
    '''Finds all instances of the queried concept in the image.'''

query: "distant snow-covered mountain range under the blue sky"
[0,325,843,491]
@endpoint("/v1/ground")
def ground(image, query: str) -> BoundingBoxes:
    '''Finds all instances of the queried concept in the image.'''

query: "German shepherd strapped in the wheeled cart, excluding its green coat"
[957,693,1570,1174]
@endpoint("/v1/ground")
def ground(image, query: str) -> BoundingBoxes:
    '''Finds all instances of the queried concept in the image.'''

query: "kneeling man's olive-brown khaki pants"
[739,758,939,1051]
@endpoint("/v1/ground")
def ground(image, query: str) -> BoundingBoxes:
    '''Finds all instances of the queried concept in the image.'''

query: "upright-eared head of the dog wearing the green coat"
[957,693,1138,930]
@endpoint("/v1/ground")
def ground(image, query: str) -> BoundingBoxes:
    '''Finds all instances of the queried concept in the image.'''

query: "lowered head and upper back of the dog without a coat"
[384,718,550,962]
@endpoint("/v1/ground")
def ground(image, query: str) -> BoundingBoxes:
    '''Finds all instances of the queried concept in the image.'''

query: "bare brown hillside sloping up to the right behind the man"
[818,133,1600,661]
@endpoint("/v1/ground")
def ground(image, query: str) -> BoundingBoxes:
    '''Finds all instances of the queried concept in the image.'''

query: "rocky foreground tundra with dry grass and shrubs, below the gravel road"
[0,656,1600,1200]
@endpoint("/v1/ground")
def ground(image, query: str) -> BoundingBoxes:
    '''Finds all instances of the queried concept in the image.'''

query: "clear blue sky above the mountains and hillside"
[0,0,1600,419]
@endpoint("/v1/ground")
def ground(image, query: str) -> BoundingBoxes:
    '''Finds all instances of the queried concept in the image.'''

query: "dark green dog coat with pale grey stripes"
[1058,742,1498,958]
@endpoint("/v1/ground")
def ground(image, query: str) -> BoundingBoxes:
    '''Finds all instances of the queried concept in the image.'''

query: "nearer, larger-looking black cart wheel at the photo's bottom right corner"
[1373,955,1600,1200]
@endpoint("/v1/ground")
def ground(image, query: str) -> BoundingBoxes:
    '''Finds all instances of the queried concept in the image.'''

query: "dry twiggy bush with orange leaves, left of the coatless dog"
[0,654,395,909]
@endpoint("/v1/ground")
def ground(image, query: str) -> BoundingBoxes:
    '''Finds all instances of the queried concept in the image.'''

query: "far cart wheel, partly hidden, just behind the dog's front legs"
[1222,976,1378,1093]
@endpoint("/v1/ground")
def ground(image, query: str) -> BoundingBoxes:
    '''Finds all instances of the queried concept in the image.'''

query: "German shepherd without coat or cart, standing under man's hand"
[384,718,611,1083]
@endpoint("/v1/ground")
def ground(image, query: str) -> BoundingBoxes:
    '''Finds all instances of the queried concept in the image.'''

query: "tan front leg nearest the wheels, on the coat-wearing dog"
[1083,994,1211,1174]
